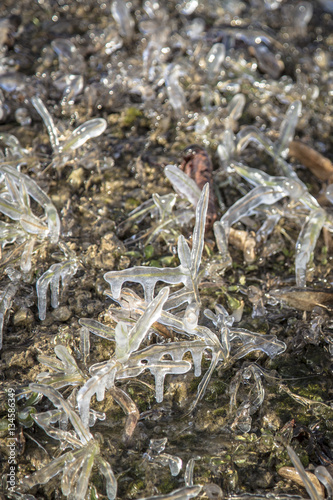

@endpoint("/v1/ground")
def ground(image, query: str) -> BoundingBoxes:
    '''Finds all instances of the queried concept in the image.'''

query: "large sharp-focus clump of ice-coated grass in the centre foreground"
[15,185,286,498]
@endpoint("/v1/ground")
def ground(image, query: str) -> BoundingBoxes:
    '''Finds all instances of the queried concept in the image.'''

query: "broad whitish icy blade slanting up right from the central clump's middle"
[128,287,170,354]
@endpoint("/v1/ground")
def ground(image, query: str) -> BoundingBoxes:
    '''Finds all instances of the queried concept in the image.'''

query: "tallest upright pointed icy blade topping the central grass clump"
[191,182,209,280]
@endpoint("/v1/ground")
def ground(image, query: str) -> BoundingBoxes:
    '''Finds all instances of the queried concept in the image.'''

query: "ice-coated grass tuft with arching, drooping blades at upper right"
[214,101,331,287]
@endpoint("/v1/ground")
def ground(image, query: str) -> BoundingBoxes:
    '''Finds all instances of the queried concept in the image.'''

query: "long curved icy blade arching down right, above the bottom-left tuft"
[29,384,93,444]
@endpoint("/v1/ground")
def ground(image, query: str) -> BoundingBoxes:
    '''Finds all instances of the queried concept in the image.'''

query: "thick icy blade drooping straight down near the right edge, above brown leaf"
[295,208,326,287]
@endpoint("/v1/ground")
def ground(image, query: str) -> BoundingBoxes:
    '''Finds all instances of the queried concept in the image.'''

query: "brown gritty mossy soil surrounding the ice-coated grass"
[0,0,333,500]
